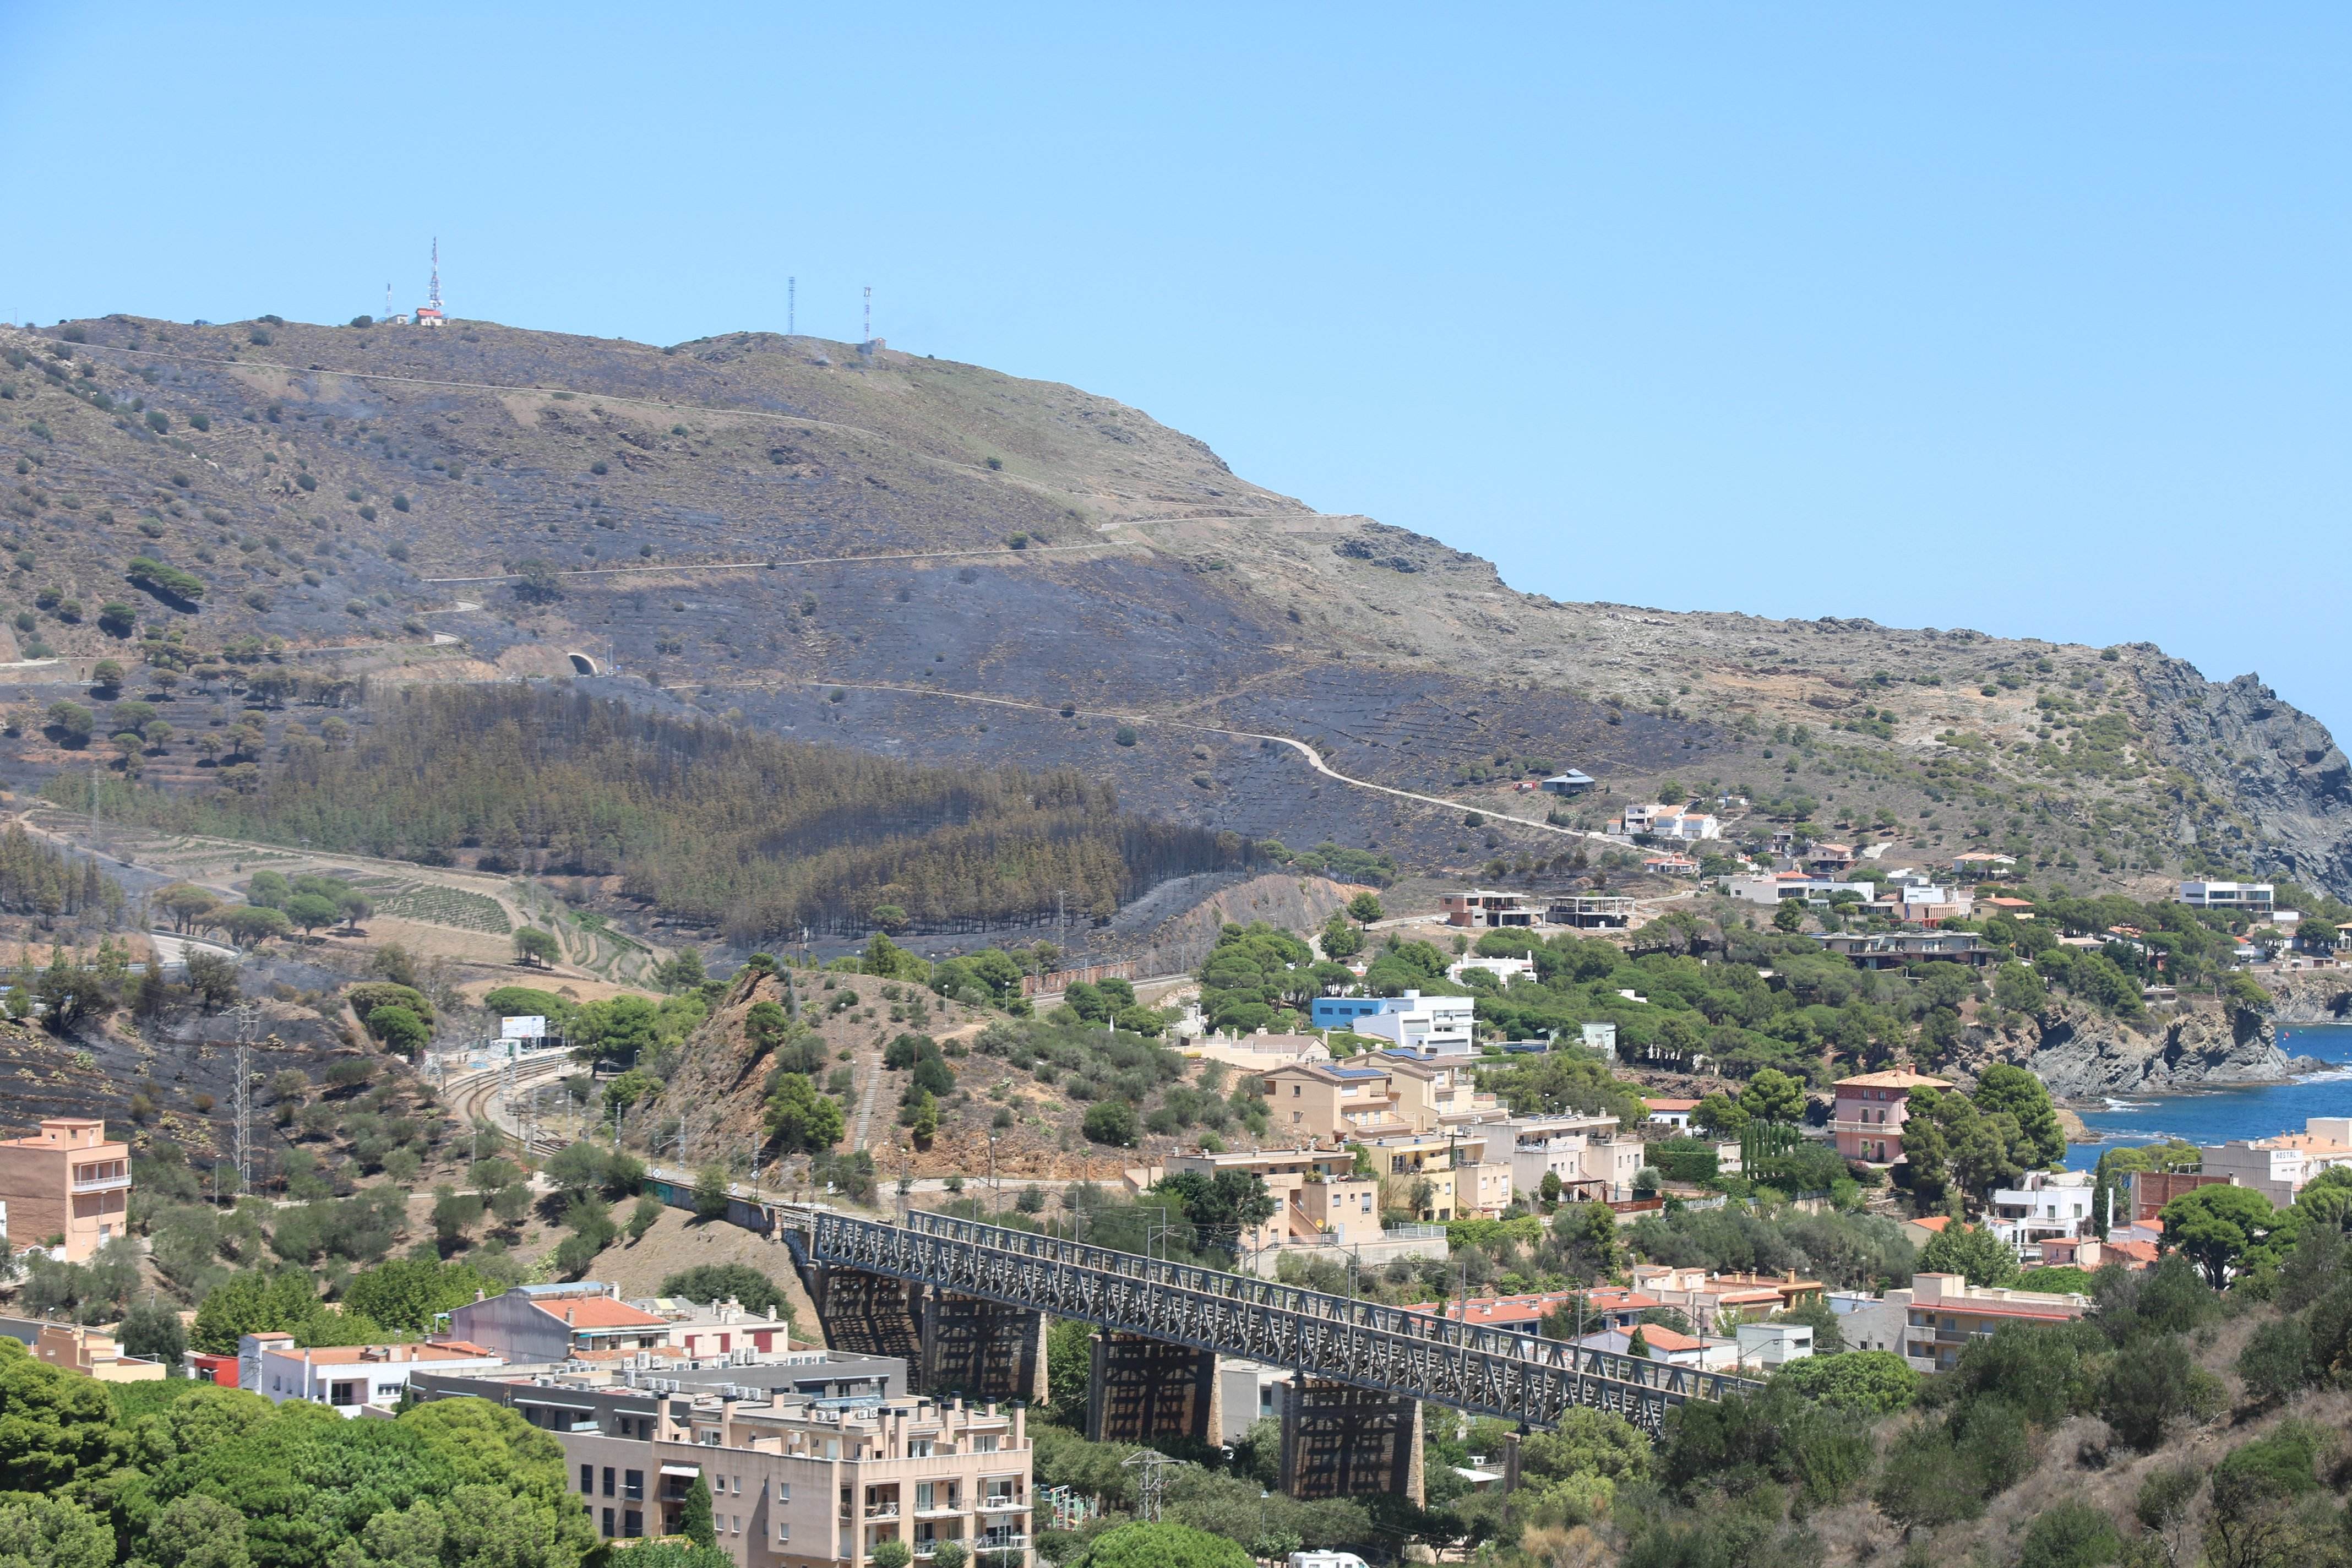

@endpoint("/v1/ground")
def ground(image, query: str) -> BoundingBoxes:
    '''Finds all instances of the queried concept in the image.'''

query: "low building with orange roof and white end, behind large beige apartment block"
[447,1281,793,1364]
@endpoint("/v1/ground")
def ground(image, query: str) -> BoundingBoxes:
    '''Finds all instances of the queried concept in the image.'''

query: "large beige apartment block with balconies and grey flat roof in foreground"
[418,1366,1032,1568]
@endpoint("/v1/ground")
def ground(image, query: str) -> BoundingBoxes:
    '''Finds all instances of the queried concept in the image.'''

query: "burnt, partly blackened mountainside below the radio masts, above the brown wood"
[0,317,2352,894]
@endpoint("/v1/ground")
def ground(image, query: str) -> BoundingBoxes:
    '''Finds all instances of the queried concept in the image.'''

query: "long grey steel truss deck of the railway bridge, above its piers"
[795,1211,1762,1434]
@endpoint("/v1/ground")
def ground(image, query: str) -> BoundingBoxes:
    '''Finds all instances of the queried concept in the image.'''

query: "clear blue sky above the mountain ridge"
[0,0,2352,733]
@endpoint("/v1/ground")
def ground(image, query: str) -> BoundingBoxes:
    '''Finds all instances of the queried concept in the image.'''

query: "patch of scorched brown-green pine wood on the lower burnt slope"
[64,687,1254,943]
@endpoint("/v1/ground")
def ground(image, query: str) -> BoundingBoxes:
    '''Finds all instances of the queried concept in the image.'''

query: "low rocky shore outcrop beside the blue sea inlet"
[1995,1004,2317,1100]
